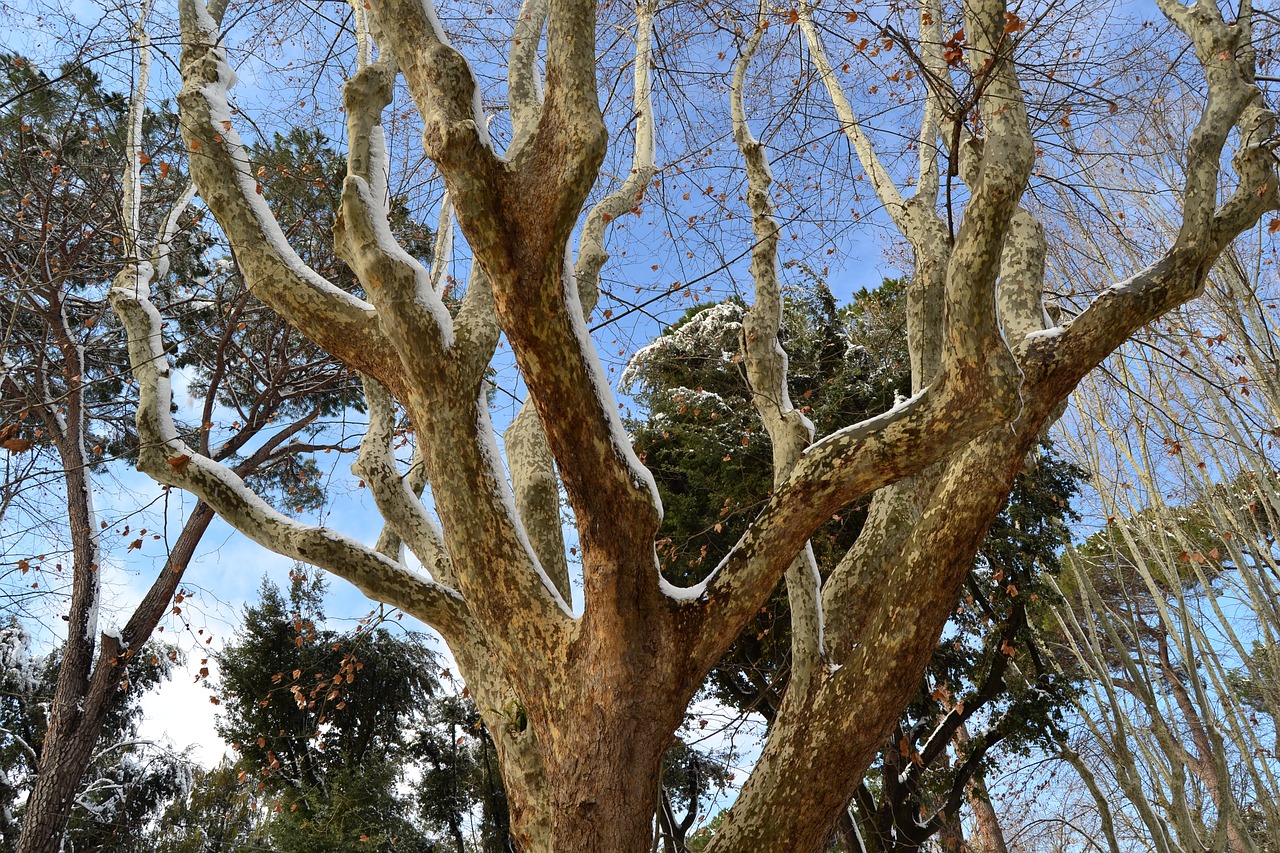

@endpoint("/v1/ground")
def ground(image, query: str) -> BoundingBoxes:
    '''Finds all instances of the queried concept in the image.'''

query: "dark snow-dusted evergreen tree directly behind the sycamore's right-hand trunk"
[623,280,1084,850]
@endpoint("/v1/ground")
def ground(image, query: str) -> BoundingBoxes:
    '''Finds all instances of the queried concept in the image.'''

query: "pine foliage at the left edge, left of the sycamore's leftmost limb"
[0,54,207,460]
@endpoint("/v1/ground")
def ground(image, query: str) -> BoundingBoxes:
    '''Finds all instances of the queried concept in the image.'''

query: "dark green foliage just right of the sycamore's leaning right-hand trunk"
[855,443,1085,847]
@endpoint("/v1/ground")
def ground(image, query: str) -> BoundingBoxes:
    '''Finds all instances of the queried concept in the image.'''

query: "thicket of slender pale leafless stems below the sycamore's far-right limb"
[1044,234,1280,853]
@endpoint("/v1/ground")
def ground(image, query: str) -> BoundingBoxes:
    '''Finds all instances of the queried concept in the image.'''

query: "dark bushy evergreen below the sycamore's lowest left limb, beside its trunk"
[199,570,508,853]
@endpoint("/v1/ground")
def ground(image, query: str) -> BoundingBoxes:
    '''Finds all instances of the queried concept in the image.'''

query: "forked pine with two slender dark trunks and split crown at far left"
[0,55,428,850]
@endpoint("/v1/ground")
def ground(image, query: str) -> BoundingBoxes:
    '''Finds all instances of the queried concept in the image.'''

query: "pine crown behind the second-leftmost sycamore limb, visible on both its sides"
[167,128,431,512]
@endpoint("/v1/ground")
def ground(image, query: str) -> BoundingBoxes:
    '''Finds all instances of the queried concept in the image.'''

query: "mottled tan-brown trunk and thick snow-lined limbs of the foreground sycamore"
[102,0,1277,853]
